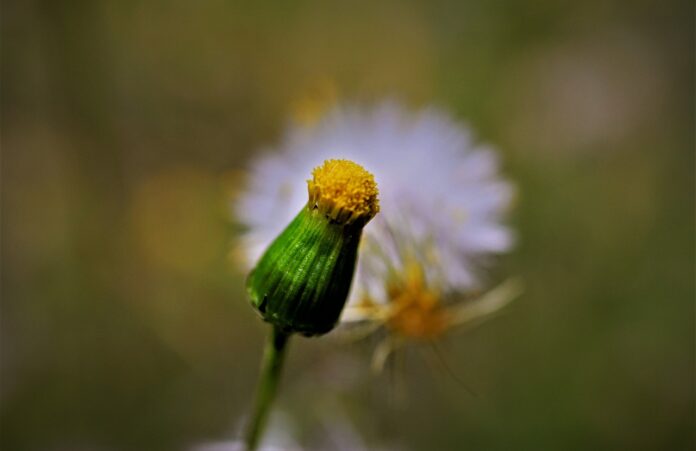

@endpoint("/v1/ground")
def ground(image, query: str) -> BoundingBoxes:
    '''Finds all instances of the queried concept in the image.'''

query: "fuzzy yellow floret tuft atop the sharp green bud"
[307,160,379,225]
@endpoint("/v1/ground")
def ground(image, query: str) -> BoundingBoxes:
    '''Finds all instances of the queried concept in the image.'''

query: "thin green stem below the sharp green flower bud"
[245,326,290,451]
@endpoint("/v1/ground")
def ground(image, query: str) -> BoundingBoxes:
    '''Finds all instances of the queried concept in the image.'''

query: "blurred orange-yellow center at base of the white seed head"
[385,262,451,339]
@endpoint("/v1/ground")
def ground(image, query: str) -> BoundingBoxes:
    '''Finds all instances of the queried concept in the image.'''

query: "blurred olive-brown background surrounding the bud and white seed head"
[0,0,695,451]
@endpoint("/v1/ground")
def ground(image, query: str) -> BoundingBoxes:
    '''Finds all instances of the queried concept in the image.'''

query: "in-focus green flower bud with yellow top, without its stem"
[247,160,379,336]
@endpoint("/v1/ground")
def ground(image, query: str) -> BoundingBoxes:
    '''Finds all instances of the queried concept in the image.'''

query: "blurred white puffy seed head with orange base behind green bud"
[234,103,516,370]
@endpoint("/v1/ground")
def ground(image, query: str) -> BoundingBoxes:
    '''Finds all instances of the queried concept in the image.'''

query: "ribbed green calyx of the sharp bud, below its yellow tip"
[247,204,363,336]
